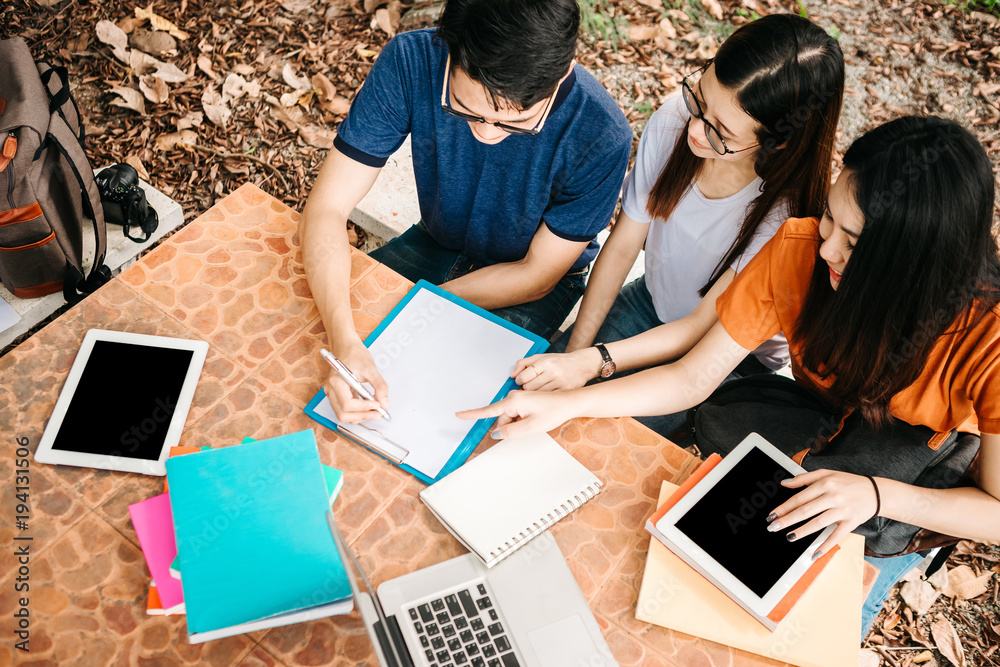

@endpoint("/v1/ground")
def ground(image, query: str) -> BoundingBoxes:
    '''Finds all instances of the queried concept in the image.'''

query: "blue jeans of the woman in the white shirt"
[549,275,774,438]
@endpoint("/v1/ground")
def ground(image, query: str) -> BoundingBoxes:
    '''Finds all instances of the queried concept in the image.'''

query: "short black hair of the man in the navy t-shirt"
[438,0,580,110]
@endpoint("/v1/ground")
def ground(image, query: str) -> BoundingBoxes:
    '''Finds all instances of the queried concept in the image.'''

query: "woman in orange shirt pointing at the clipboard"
[460,117,1000,636]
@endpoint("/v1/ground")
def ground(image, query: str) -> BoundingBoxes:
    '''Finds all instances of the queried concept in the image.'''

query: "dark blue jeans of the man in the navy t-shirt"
[370,223,589,340]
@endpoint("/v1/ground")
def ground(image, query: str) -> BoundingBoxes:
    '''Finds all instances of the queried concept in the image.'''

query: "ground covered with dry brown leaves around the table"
[0,0,1000,667]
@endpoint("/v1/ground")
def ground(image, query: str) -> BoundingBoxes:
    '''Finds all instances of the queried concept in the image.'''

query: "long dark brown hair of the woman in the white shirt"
[647,14,844,296]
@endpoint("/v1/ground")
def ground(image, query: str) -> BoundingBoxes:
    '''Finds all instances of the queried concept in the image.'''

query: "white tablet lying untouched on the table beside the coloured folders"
[35,329,208,475]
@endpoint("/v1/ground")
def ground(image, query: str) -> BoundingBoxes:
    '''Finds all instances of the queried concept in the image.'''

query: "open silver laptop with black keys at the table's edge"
[327,512,618,667]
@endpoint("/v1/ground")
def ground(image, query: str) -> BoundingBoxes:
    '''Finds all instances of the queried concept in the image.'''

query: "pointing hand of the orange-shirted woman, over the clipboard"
[455,391,577,439]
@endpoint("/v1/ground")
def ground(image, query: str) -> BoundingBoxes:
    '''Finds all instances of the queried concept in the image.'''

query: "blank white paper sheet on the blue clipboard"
[316,289,533,478]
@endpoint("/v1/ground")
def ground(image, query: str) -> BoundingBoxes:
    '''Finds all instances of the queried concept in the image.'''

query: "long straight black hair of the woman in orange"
[795,116,1000,426]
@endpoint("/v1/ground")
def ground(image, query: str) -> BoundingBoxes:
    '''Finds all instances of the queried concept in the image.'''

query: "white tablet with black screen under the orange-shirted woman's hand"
[656,433,836,618]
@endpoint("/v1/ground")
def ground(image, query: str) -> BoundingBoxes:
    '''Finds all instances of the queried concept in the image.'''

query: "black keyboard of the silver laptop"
[409,584,520,667]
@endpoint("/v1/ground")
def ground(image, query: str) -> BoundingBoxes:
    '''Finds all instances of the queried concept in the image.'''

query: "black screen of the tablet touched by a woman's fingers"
[675,447,812,597]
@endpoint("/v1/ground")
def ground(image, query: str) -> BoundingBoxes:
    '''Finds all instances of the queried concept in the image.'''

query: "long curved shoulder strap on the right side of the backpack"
[39,115,111,303]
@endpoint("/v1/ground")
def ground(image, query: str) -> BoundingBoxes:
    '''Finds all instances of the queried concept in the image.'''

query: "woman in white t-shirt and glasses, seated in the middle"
[515,15,844,436]
